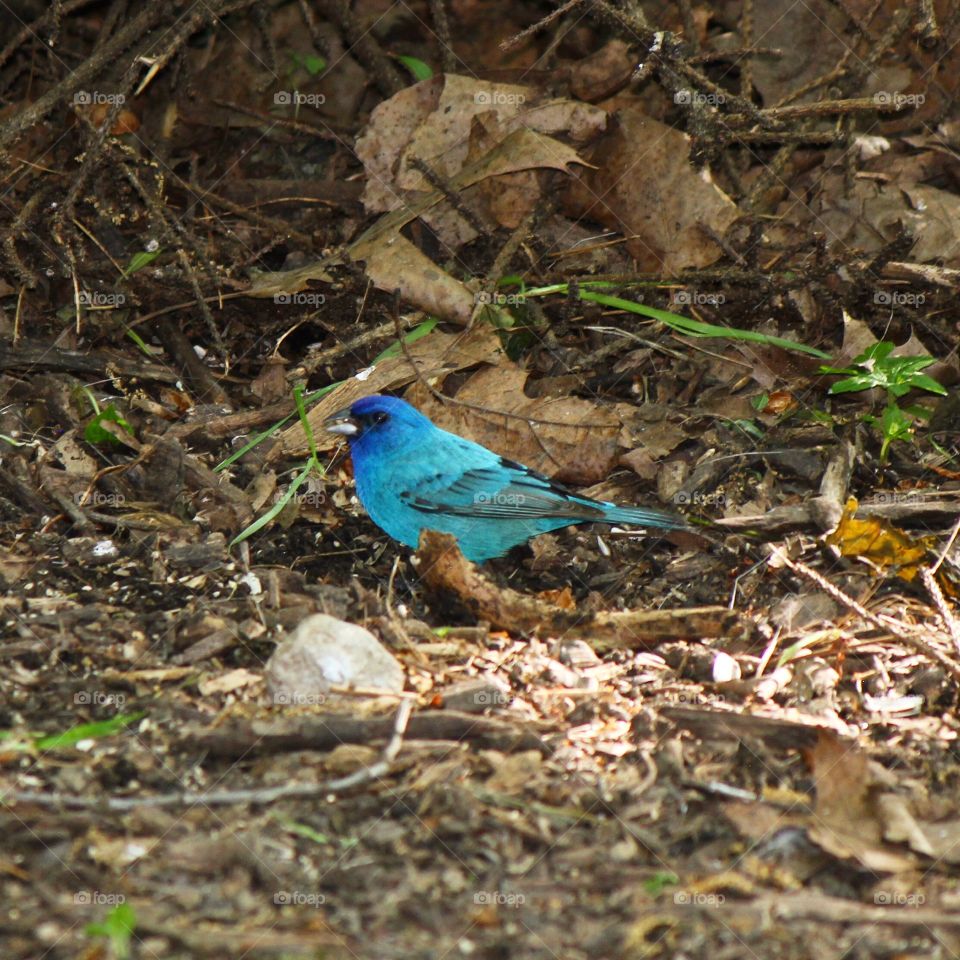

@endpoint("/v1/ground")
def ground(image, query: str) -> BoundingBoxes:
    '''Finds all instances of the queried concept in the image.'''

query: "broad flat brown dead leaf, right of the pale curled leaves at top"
[566,108,738,276]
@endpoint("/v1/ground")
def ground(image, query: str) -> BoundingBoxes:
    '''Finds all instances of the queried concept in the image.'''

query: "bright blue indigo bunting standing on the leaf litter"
[326,394,687,563]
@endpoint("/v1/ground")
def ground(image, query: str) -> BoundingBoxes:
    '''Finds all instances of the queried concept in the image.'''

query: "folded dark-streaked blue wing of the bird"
[400,457,606,523]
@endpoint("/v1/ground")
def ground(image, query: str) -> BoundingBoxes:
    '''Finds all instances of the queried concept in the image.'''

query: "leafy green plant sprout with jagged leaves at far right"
[820,340,947,464]
